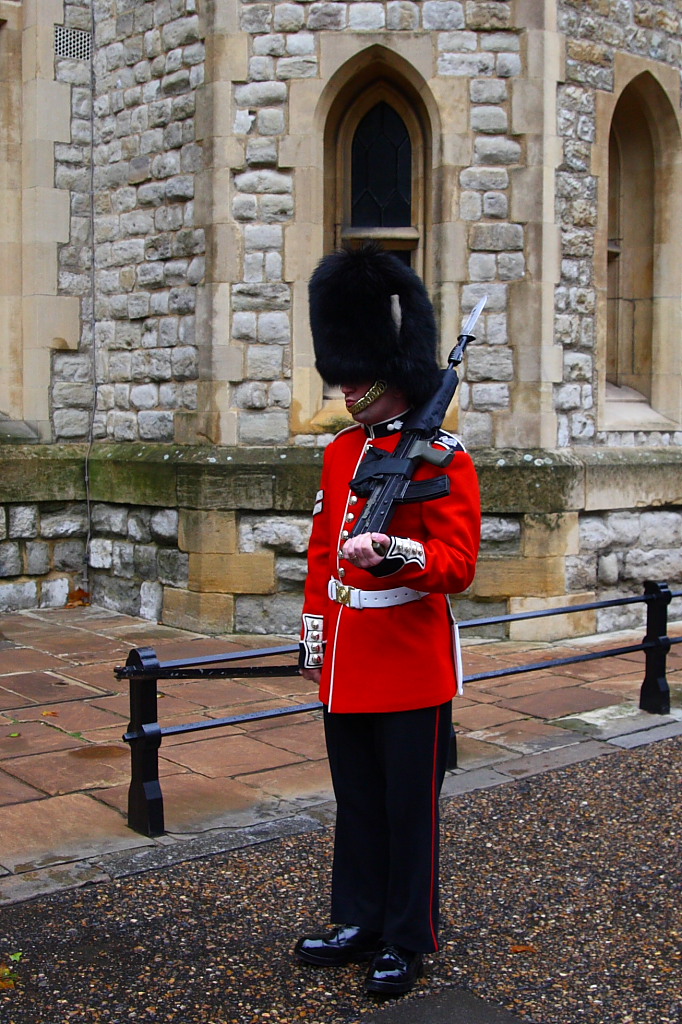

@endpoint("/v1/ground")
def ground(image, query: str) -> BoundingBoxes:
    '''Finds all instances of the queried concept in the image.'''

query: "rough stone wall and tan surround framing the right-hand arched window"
[554,0,682,446]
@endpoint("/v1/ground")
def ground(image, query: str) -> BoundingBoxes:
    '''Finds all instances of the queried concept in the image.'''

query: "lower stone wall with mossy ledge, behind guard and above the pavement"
[0,444,682,639]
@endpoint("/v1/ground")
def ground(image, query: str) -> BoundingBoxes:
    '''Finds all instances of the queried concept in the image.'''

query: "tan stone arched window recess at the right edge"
[602,72,682,430]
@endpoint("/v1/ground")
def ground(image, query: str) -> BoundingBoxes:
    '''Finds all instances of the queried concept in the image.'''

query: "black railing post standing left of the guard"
[126,647,166,836]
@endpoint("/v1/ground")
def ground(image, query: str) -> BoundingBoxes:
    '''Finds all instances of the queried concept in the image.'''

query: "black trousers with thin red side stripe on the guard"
[325,701,452,952]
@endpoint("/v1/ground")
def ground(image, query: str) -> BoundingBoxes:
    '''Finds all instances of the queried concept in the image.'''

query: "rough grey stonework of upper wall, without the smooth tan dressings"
[51,0,682,447]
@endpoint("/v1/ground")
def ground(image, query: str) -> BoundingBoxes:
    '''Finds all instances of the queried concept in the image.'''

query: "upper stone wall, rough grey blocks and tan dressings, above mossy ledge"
[43,0,682,449]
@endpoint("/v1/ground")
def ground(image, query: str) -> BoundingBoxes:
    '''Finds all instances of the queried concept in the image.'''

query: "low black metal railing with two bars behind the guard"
[114,582,682,836]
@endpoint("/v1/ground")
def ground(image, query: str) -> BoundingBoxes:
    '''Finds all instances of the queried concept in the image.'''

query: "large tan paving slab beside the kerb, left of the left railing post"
[0,794,151,872]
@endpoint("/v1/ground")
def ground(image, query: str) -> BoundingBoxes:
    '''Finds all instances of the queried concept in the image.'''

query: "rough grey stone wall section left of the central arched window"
[51,0,206,441]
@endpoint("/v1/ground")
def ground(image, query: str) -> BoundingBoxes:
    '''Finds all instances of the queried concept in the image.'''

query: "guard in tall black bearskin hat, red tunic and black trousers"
[295,245,480,995]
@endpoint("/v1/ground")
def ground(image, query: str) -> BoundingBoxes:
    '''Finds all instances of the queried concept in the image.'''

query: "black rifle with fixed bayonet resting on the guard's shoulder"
[350,296,487,553]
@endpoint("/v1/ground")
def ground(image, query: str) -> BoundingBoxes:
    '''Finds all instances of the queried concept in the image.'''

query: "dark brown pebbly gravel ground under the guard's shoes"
[0,739,682,1024]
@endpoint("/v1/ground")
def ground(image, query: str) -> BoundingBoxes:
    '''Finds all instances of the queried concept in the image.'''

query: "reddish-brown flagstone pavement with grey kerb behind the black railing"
[0,607,682,903]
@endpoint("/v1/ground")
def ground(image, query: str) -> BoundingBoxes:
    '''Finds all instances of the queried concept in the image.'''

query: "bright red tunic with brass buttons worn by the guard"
[303,425,480,713]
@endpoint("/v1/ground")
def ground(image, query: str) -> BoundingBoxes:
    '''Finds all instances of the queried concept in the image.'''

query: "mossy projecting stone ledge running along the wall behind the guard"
[0,443,682,515]
